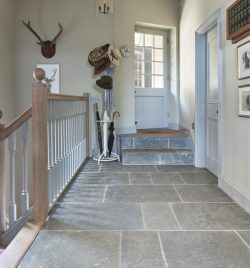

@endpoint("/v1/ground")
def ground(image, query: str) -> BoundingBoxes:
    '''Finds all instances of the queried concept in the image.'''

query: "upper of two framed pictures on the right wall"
[238,41,250,79]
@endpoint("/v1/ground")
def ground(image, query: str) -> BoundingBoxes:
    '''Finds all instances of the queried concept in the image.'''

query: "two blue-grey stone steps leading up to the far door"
[117,131,194,165]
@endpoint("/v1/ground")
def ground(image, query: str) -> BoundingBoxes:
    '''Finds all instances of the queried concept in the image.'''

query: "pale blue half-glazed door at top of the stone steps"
[134,28,168,129]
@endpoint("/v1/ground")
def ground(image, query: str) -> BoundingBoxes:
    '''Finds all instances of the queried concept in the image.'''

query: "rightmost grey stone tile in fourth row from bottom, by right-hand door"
[180,172,218,184]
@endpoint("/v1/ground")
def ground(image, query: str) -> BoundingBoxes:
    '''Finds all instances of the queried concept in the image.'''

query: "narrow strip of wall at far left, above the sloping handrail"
[0,0,15,124]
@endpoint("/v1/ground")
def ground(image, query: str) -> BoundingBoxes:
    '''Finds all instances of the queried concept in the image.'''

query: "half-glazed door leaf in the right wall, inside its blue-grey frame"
[206,28,218,175]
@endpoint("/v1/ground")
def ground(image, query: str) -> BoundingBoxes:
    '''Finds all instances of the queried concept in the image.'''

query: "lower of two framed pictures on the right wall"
[239,85,250,117]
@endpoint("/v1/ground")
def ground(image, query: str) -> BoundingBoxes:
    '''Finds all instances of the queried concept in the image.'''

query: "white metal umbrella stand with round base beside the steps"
[93,90,120,164]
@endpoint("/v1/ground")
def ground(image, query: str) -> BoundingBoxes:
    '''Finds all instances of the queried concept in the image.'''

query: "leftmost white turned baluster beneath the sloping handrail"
[8,132,17,225]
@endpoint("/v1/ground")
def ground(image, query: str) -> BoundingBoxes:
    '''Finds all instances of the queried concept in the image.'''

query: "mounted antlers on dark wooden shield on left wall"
[22,21,63,59]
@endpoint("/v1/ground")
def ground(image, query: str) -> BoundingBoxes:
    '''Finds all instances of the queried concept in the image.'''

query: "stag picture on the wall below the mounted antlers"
[37,64,60,94]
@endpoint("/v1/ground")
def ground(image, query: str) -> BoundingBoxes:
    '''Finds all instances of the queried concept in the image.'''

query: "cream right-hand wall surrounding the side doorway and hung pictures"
[180,0,250,212]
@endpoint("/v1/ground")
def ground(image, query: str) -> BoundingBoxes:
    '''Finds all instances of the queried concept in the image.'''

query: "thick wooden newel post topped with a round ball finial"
[32,68,48,221]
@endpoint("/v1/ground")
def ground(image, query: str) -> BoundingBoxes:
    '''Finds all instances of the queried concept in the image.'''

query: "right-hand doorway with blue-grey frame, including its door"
[195,10,222,176]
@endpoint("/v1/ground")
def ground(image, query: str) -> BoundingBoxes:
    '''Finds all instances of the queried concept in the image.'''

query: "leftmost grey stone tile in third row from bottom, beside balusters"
[59,183,106,202]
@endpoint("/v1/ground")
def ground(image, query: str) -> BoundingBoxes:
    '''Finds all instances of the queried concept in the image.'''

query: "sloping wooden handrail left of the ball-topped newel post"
[0,107,32,141]
